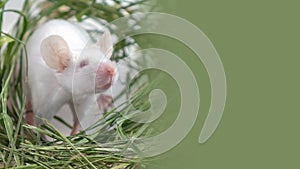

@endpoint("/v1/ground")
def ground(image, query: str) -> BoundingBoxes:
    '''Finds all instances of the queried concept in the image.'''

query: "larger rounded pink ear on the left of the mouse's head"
[40,35,71,72]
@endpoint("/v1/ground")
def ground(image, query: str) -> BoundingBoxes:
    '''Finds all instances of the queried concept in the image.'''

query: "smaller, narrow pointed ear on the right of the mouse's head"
[97,30,113,58]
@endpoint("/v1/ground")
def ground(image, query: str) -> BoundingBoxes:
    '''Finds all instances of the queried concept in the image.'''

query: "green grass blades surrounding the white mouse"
[0,0,155,169]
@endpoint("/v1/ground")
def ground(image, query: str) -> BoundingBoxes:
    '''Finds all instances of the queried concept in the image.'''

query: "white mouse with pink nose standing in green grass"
[23,20,117,134]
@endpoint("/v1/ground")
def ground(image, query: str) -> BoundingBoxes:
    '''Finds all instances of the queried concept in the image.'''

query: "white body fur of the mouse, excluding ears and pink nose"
[23,20,112,124]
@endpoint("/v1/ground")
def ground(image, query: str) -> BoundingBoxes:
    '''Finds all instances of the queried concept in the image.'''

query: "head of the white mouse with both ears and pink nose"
[40,31,116,94]
